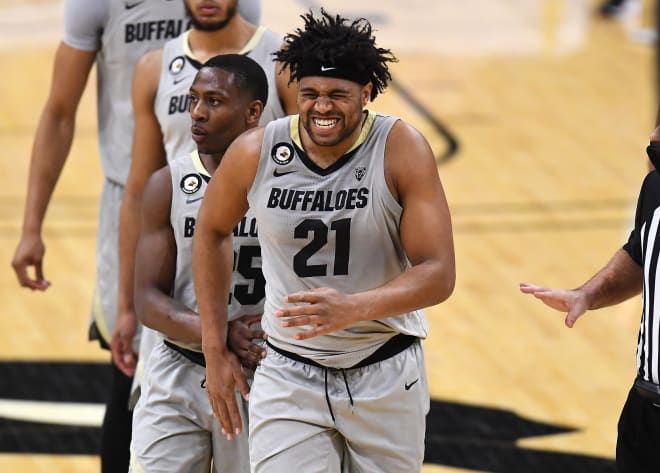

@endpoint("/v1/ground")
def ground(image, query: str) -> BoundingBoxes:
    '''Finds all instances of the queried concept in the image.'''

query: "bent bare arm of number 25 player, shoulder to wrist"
[135,166,201,343]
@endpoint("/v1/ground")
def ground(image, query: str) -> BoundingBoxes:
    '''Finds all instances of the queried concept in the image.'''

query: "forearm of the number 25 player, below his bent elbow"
[136,288,202,344]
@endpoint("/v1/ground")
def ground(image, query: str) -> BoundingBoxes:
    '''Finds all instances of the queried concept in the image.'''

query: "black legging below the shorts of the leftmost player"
[101,363,133,473]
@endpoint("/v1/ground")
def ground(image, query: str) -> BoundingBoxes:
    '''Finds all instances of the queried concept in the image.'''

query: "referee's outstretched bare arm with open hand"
[520,249,644,328]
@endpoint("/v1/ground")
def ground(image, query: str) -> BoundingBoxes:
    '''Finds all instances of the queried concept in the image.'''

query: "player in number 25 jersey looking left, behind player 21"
[131,54,268,473]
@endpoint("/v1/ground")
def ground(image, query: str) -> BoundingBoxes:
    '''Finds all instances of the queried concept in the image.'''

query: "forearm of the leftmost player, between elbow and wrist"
[23,107,75,234]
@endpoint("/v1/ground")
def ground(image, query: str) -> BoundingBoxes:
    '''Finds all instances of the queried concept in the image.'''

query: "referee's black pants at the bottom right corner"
[616,387,660,473]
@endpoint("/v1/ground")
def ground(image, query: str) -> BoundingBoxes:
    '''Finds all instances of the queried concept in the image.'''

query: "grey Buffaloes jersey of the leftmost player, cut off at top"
[96,0,188,185]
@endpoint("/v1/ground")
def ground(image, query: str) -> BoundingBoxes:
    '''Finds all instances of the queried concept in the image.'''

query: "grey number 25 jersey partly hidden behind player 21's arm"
[170,151,266,351]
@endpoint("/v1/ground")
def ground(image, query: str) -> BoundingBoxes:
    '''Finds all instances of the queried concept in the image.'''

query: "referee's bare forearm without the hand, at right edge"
[576,250,644,310]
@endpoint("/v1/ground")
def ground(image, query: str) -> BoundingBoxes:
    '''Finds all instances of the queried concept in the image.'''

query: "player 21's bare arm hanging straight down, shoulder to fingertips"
[193,129,263,439]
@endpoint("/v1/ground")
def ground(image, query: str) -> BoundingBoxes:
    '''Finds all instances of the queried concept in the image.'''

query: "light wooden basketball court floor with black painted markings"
[0,0,657,473]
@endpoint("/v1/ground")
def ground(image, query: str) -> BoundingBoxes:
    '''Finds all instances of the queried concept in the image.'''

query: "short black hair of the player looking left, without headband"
[200,54,268,107]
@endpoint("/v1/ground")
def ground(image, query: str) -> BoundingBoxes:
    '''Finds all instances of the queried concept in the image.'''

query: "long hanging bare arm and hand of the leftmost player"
[12,43,96,291]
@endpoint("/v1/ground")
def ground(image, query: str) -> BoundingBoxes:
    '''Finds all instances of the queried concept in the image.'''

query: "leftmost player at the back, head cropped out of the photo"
[12,0,260,473]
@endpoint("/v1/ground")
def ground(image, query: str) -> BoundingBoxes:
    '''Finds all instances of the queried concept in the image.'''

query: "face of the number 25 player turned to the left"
[190,67,250,155]
